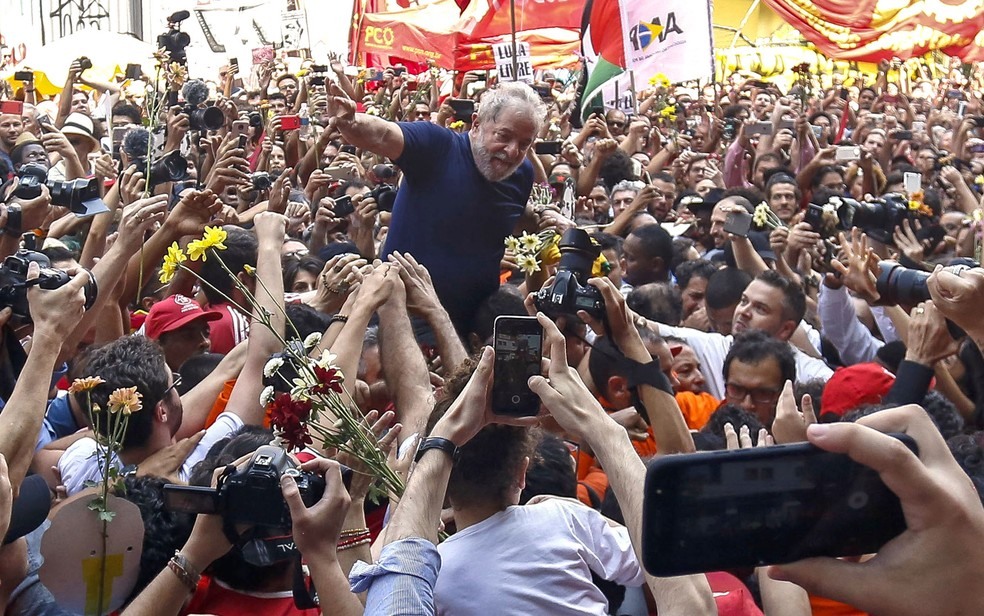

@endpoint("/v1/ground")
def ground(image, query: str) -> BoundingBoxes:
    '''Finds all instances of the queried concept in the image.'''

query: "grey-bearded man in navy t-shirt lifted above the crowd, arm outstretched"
[328,83,545,330]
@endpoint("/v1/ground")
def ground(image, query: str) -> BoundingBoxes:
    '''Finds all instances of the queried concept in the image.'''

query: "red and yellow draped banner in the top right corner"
[765,0,984,62]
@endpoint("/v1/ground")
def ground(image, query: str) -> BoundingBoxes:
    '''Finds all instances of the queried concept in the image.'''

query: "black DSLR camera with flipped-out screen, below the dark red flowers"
[164,445,325,529]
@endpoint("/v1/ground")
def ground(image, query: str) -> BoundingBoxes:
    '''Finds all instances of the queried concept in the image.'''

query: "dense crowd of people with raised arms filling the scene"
[0,39,984,616]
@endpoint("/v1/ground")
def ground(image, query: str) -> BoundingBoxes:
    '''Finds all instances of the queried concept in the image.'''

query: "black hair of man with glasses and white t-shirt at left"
[75,336,173,449]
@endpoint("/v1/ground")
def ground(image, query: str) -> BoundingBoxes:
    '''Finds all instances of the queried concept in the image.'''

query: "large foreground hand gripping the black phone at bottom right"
[769,405,984,616]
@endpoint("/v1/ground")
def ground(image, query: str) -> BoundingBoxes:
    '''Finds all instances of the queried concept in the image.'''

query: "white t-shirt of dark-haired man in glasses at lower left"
[58,413,243,496]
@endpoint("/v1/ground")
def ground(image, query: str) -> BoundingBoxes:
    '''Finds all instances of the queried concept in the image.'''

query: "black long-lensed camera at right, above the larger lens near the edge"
[803,193,925,245]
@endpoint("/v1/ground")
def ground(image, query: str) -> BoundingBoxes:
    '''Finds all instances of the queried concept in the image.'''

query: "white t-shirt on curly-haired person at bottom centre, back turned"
[434,499,645,616]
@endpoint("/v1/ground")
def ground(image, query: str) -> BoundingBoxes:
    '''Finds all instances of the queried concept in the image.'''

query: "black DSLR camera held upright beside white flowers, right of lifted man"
[534,229,605,320]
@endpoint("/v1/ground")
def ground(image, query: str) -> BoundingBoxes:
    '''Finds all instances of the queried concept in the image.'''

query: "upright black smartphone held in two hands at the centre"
[492,315,543,417]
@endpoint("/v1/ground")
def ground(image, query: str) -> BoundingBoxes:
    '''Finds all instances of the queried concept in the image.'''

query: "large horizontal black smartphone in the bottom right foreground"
[642,434,918,577]
